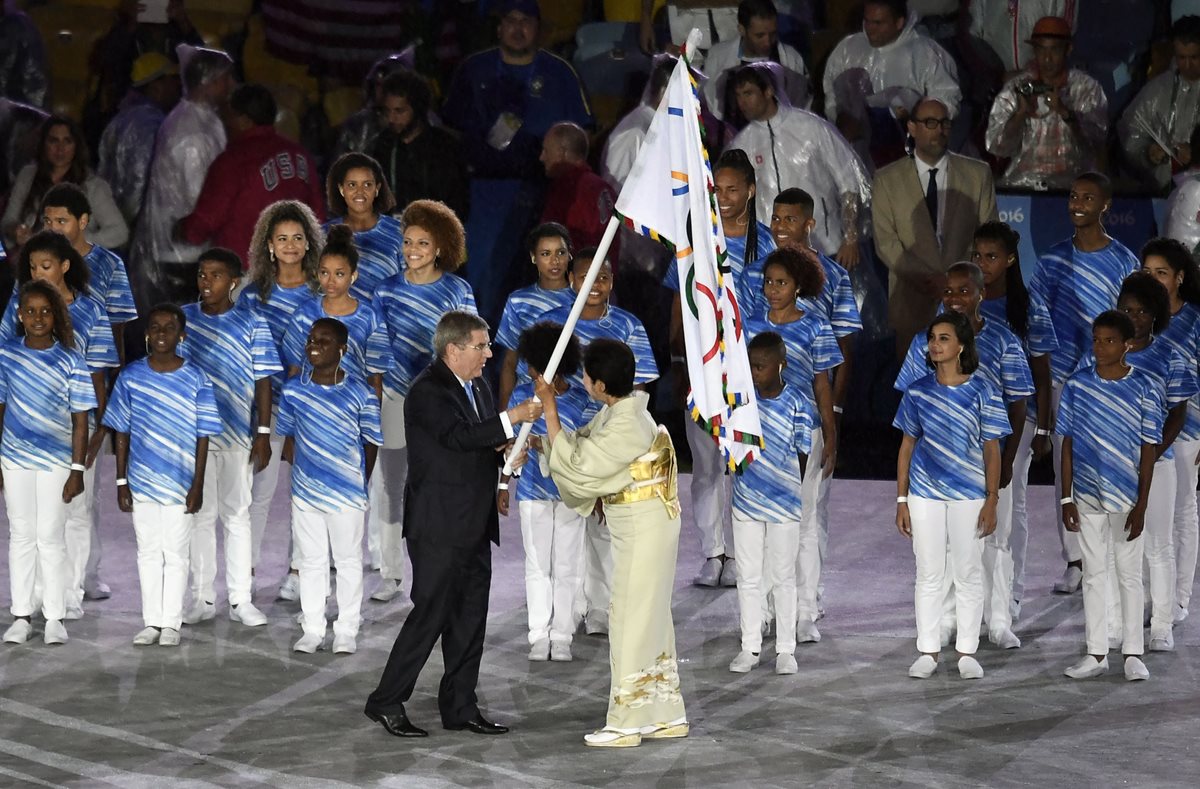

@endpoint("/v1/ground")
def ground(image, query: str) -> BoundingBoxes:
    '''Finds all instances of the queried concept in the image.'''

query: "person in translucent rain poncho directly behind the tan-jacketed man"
[824,0,962,167]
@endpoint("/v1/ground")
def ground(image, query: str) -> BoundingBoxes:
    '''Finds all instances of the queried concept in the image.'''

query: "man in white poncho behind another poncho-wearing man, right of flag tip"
[704,0,812,122]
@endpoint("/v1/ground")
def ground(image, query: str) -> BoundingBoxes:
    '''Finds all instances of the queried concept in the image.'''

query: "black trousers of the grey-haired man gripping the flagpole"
[366,537,492,725]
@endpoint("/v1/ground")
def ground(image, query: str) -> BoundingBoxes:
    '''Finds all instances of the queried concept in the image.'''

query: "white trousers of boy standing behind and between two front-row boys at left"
[191,448,254,606]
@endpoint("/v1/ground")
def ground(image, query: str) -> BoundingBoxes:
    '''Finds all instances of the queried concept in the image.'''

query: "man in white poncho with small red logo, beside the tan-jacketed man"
[730,62,871,269]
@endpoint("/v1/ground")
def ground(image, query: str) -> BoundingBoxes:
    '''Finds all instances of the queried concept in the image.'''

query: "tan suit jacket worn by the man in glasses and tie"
[871,153,998,335]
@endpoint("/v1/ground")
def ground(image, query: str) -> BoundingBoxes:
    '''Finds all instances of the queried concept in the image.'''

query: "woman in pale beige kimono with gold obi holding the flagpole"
[535,339,688,748]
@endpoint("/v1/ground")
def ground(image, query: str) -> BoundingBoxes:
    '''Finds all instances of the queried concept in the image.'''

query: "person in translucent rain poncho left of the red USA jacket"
[130,44,233,305]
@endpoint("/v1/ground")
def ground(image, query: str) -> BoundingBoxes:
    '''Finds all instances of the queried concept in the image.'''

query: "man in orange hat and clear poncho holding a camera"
[986,17,1108,189]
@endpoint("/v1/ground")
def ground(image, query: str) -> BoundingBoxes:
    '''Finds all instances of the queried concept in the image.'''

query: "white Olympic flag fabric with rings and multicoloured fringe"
[616,40,763,471]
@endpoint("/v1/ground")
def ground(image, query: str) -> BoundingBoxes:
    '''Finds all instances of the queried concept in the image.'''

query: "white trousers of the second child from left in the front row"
[133,499,192,630]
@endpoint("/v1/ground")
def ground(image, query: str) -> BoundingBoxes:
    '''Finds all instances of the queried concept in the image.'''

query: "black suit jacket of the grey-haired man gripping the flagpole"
[404,360,508,547]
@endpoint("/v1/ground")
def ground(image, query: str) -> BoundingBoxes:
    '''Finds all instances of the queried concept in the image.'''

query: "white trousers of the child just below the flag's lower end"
[733,513,800,655]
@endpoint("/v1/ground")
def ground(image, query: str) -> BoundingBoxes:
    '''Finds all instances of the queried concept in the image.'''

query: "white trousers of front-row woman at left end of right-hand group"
[908,495,984,655]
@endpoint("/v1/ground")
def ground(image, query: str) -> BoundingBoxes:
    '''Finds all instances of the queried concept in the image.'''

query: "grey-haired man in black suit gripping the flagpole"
[365,312,541,737]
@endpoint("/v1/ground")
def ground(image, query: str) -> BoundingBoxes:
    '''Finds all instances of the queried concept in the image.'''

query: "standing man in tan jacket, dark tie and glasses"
[871,98,997,359]
